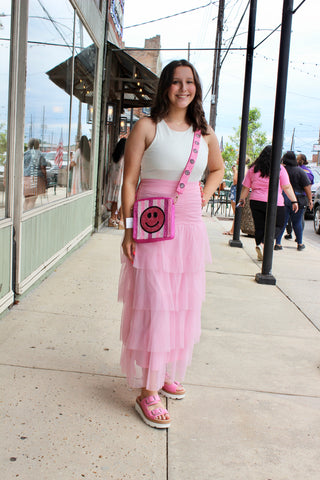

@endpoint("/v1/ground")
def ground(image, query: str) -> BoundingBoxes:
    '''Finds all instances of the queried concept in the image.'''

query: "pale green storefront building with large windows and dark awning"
[0,0,157,313]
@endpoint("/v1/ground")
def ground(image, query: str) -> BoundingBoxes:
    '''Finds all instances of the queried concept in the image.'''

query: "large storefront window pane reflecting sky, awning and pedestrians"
[24,0,96,211]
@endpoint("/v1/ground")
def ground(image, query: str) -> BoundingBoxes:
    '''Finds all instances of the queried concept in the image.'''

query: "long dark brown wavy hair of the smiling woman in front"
[151,60,208,135]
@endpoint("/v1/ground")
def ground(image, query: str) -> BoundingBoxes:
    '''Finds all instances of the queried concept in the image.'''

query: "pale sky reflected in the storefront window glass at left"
[0,0,93,146]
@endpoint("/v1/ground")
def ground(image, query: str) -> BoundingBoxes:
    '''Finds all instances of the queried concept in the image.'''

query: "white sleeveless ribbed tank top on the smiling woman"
[141,120,208,182]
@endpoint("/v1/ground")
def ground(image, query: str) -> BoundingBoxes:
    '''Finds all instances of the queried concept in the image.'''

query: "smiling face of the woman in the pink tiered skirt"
[168,66,196,108]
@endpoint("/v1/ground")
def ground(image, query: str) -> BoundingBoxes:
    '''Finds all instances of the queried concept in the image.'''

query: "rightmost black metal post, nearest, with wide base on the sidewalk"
[256,0,293,285]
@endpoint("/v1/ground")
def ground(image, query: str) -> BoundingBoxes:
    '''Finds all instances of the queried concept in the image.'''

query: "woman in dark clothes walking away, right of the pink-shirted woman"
[274,152,313,251]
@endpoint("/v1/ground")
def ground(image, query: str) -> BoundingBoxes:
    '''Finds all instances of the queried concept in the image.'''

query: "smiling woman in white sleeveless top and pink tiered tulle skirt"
[119,60,224,428]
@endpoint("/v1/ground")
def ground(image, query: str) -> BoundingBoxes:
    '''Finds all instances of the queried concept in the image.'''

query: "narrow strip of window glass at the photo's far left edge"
[0,0,11,219]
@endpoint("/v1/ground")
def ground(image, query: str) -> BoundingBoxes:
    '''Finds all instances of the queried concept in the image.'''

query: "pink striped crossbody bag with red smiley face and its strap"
[133,130,201,243]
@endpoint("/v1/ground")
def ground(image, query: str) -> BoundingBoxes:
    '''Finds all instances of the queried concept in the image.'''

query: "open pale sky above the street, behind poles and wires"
[123,0,320,160]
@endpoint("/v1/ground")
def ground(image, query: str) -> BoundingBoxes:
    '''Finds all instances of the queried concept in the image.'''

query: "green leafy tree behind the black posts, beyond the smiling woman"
[230,108,267,161]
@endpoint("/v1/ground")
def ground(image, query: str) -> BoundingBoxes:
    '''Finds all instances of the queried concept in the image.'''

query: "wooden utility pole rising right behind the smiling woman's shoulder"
[209,0,225,130]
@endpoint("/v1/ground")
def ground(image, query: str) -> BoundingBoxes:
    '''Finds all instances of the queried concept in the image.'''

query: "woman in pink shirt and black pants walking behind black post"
[239,145,298,260]
